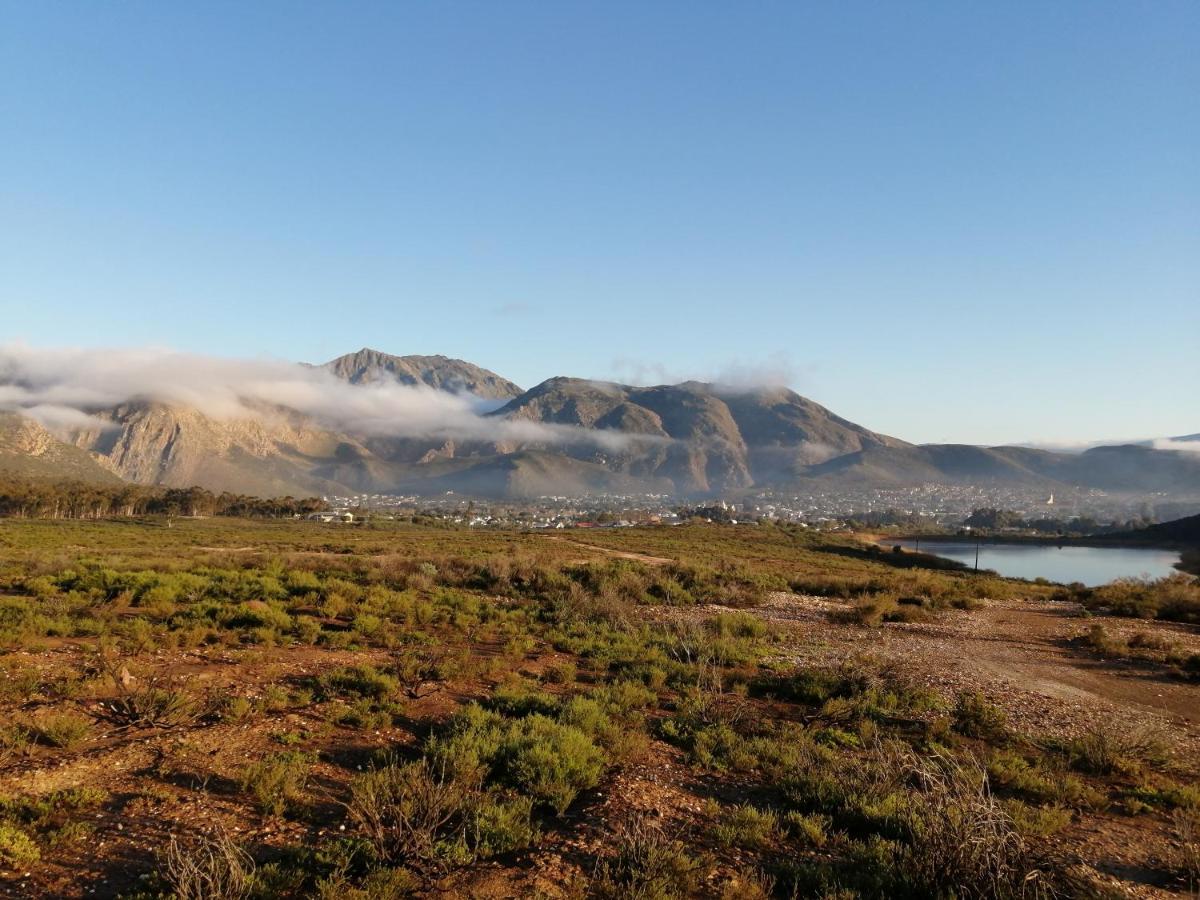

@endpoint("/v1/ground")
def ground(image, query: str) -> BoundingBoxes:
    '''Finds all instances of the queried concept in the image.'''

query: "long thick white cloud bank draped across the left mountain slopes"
[0,343,629,449]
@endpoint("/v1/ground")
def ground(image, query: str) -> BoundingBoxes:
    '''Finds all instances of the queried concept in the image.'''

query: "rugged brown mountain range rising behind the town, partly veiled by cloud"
[0,349,1200,497]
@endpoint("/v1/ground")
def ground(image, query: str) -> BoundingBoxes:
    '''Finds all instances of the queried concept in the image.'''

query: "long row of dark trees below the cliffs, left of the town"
[0,475,326,518]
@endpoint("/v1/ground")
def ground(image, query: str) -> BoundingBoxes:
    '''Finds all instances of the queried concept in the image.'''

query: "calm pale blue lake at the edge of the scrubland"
[881,540,1180,587]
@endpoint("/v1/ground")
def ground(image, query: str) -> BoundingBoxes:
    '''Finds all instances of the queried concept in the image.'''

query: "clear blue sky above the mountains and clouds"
[0,0,1200,443]
